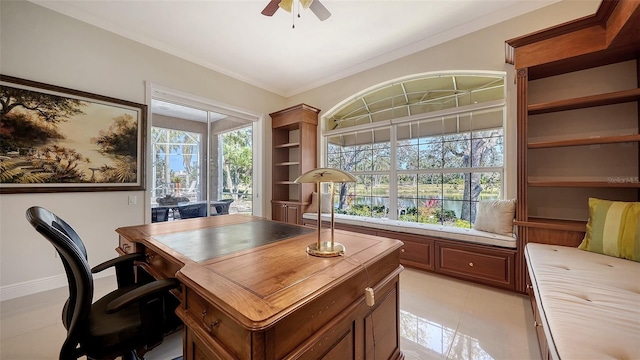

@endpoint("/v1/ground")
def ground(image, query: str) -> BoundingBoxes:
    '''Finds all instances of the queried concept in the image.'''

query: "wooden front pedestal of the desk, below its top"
[178,255,403,359]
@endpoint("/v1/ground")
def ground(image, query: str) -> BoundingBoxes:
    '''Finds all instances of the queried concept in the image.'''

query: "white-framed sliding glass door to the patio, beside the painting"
[149,89,257,222]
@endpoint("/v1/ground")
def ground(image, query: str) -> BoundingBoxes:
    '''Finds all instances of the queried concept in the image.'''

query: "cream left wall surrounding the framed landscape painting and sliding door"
[0,1,285,299]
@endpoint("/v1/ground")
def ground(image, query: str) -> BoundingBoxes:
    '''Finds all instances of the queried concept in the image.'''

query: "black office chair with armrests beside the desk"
[26,206,180,360]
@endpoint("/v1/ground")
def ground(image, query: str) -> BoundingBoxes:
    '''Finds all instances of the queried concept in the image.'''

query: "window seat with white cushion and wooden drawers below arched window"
[302,212,516,291]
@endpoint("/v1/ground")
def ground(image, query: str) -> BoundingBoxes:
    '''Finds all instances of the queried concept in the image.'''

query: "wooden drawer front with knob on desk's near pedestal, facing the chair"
[184,287,251,359]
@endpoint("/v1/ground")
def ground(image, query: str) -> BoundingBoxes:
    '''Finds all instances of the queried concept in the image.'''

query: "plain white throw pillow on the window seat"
[473,199,516,236]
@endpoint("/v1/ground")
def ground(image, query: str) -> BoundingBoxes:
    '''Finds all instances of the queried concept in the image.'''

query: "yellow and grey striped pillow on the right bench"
[579,198,640,262]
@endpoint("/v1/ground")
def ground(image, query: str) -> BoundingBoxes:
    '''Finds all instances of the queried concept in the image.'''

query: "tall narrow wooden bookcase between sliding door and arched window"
[269,104,320,224]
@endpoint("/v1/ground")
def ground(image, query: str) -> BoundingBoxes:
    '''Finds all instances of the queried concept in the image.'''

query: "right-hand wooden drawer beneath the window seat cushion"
[436,242,515,289]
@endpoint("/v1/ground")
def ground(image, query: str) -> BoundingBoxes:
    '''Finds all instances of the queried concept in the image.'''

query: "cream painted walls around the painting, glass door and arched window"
[0,0,599,299]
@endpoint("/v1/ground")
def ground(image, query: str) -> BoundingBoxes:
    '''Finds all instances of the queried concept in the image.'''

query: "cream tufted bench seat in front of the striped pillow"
[525,243,640,360]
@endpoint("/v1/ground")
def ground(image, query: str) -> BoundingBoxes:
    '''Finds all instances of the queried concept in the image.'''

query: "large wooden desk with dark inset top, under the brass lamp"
[117,215,404,359]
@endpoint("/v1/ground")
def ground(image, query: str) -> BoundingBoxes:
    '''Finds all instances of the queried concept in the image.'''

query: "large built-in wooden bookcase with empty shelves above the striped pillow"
[506,0,640,292]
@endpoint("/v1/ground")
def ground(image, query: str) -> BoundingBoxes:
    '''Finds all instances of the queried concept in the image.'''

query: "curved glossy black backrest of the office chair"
[26,206,93,359]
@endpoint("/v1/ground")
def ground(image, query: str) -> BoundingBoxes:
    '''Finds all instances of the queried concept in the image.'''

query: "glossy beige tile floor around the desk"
[0,269,540,360]
